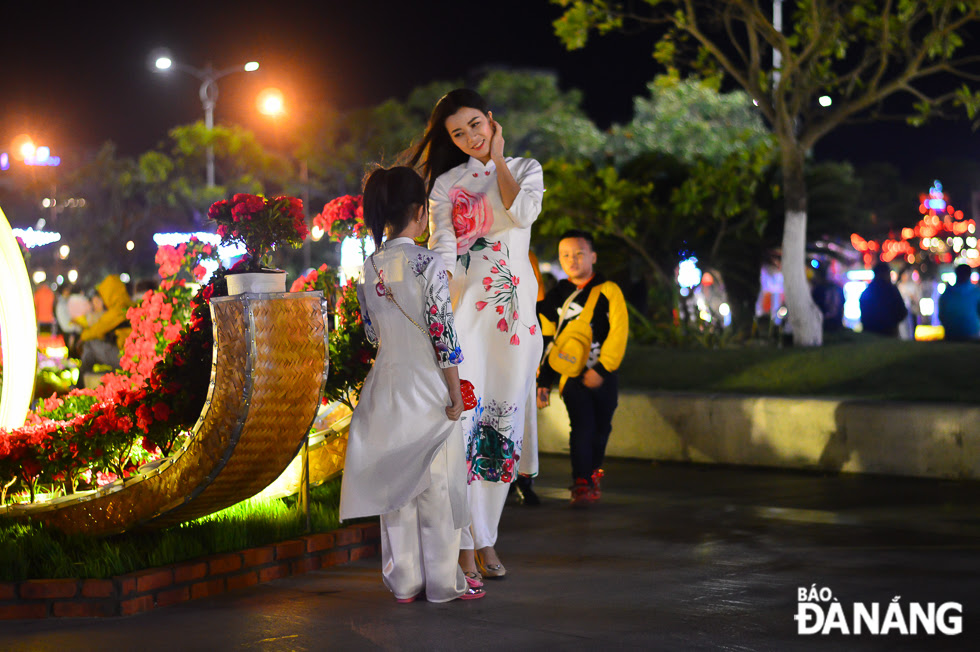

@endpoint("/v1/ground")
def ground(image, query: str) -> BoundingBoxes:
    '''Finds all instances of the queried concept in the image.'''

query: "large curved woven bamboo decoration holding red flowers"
[0,292,329,535]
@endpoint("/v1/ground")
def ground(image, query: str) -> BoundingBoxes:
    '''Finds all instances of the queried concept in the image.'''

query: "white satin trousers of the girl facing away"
[381,444,466,602]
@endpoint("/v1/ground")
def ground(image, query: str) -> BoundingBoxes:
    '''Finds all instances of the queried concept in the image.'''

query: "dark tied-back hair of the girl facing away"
[364,166,425,247]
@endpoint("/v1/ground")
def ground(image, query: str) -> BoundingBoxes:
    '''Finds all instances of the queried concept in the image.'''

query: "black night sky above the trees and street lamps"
[0,0,980,191]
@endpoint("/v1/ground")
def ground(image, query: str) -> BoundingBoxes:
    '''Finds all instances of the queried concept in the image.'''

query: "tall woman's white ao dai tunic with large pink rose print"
[429,158,544,482]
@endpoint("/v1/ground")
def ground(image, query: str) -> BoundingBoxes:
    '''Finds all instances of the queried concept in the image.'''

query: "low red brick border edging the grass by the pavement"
[0,523,381,620]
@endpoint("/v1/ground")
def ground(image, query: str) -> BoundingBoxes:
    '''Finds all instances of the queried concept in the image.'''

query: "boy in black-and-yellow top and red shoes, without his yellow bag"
[537,229,629,507]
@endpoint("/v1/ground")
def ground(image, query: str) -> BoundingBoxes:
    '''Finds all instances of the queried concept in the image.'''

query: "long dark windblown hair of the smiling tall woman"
[406,88,490,194]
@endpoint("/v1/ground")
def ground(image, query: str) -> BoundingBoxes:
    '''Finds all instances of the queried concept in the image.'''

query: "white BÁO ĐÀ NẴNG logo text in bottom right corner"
[793,584,963,636]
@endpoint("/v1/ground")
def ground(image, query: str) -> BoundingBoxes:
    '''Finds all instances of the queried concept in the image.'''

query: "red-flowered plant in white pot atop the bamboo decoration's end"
[208,193,308,294]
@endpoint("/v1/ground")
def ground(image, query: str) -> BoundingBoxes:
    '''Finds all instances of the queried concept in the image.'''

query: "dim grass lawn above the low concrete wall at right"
[620,332,980,403]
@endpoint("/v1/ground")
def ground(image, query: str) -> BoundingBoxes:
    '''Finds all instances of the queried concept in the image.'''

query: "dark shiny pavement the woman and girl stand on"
[0,456,980,652]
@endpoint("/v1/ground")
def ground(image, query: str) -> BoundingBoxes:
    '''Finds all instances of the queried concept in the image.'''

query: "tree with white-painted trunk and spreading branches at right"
[552,0,980,345]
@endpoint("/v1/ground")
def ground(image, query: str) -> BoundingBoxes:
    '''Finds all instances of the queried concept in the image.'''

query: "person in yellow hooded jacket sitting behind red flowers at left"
[78,274,132,384]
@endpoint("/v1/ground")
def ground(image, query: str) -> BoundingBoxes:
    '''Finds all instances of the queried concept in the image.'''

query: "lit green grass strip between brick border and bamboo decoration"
[0,478,340,581]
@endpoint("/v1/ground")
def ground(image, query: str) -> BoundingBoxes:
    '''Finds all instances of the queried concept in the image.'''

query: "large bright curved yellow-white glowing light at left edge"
[0,204,37,430]
